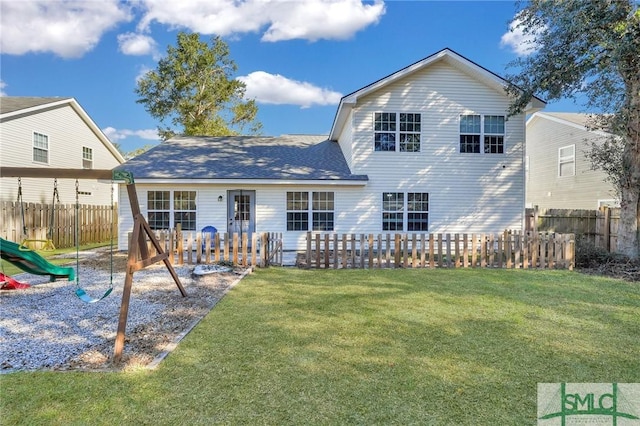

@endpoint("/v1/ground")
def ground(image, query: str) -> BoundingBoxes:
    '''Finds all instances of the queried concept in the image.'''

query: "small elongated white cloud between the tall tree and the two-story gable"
[238,71,342,108]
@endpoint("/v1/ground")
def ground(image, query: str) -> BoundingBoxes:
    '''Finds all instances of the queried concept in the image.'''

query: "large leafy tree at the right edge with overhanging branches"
[508,0,640,258]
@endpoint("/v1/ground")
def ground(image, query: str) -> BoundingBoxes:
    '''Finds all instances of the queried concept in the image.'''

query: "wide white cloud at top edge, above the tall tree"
[138,0,385,41]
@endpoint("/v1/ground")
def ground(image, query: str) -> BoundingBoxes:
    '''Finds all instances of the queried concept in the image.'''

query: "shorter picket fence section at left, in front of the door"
[135,229,282,267]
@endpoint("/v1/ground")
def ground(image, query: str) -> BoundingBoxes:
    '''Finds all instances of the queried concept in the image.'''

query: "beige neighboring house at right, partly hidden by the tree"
[527,112,619,210]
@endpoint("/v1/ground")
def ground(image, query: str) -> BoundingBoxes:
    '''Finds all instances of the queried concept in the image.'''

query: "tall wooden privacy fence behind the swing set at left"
[0,201,118,248]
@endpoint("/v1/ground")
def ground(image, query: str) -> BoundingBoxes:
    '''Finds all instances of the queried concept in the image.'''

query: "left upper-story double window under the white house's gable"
[373,112,421,152]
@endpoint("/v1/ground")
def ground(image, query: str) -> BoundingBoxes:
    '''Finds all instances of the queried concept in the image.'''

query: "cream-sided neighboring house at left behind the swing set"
[0,96,124,205]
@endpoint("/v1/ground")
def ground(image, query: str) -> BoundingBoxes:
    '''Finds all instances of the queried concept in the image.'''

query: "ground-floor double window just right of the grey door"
[287,191,334,231]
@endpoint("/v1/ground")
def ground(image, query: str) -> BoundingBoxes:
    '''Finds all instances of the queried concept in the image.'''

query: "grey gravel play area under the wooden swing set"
[0,250,248,373]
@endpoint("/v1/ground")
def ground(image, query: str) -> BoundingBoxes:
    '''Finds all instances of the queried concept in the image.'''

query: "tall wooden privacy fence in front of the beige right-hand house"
[525,207,620,251]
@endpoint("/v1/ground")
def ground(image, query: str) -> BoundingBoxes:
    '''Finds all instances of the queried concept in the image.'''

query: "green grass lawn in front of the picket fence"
[0,268,640,425]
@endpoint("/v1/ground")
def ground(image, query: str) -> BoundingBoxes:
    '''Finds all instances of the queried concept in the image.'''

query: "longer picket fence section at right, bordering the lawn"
[306,231,575,270]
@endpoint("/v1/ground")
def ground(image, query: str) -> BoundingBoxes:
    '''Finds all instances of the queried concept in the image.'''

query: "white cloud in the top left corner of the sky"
[0,0,131,58]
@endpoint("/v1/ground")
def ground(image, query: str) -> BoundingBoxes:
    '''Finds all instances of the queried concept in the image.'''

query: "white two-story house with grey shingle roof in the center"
[119,49,545,250]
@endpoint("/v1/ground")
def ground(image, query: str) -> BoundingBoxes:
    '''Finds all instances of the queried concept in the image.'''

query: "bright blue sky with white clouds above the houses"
[0,0,582,152]
